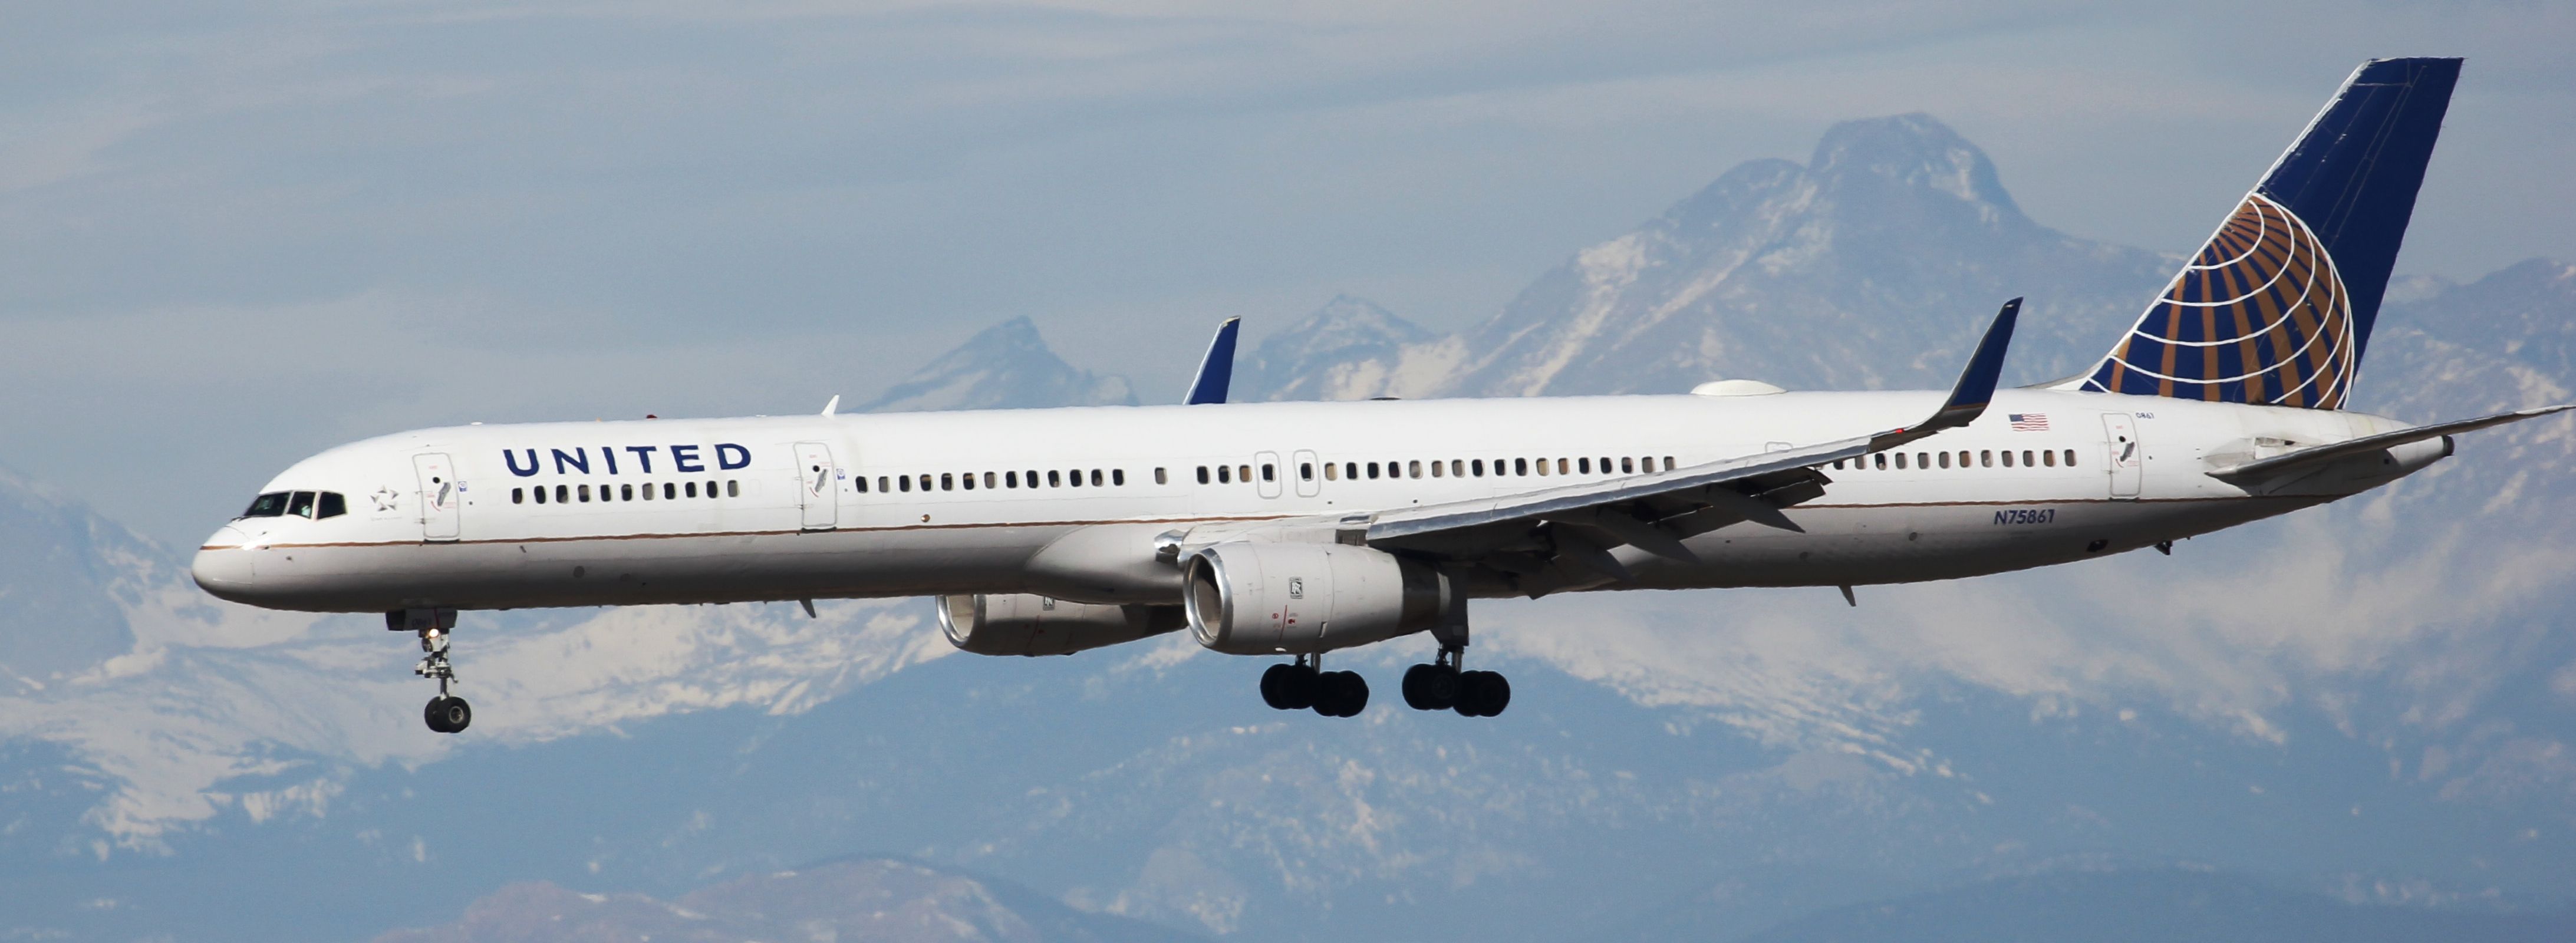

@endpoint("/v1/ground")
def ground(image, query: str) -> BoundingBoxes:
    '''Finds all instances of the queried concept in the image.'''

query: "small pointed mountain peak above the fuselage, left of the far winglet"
[852,317,1136,412]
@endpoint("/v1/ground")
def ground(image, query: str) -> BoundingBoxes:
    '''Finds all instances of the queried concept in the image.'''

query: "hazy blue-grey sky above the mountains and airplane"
[0,2,2576,543]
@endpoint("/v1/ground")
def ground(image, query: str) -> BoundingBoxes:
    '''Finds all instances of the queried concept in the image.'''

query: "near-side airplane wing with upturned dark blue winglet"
[1345,299,2022,585]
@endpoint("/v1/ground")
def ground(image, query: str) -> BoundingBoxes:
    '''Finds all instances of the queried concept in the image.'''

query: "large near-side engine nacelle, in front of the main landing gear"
[1182,543,1450,654]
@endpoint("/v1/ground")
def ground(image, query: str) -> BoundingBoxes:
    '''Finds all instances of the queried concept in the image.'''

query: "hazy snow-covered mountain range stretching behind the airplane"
[0,118,2576,941]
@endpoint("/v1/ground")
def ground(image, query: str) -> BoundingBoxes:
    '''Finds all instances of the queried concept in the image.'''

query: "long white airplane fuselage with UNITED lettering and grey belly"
[196,389,2439,611]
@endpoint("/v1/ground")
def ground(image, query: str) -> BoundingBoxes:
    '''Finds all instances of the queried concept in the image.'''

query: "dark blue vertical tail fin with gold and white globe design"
[2081,60,2460,410]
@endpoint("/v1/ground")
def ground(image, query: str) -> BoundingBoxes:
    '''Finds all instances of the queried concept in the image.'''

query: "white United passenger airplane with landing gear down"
[190,60,2568,734]
